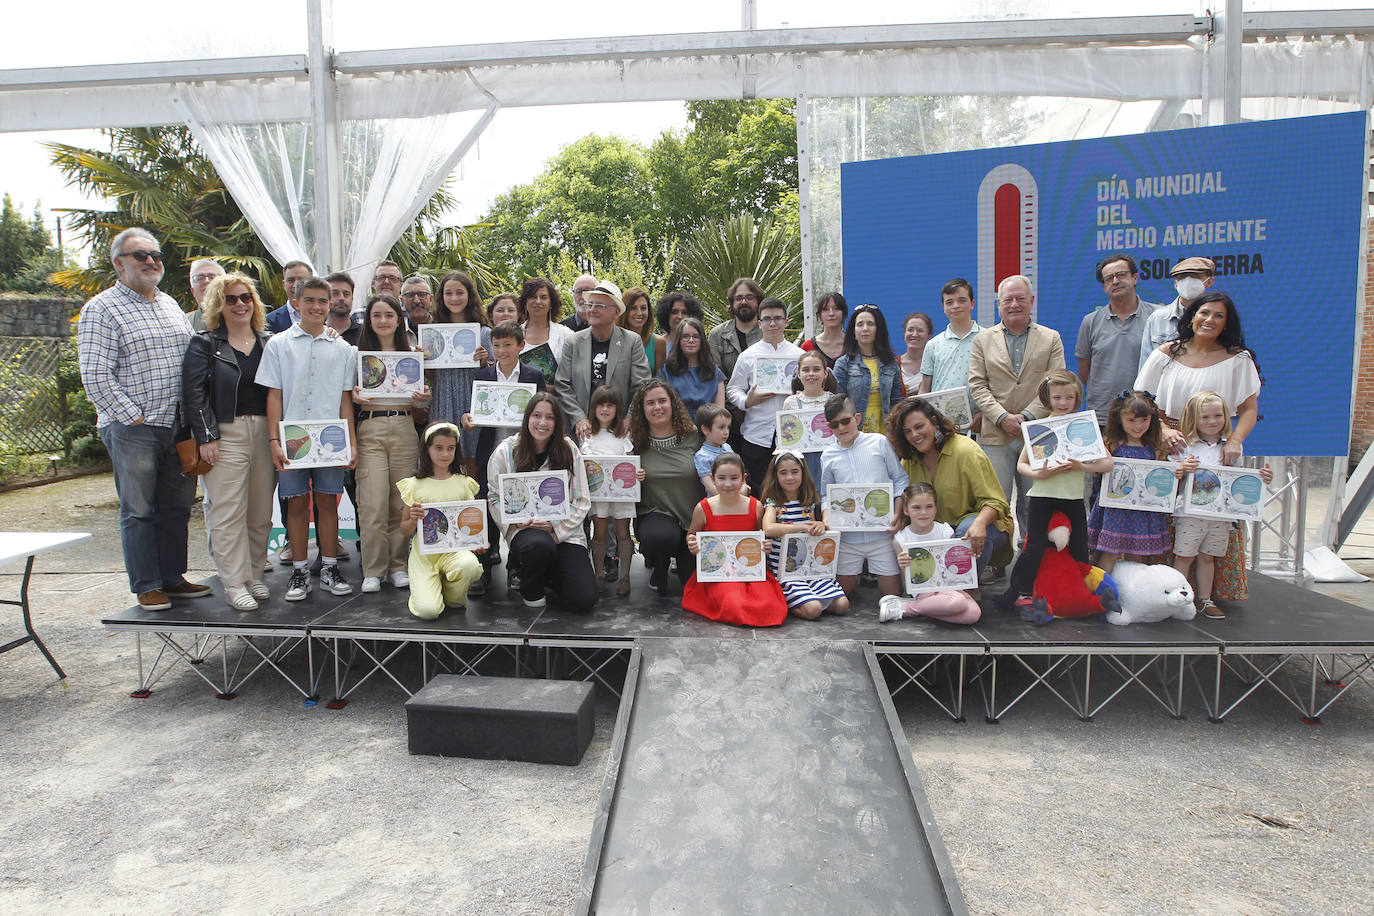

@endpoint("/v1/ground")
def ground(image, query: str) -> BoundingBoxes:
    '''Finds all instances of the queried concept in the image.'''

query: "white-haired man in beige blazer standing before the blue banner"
[969,273,1066,565]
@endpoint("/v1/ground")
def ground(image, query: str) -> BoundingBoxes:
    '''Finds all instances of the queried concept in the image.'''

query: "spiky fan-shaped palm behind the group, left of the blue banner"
[673,213,802,327]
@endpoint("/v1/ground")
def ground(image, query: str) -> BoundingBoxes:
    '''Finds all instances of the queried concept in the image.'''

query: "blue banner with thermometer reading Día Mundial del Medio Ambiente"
[841,111,1364,456]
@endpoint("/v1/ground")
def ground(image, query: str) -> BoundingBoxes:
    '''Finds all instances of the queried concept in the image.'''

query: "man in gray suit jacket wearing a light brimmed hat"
[554,280,649,439]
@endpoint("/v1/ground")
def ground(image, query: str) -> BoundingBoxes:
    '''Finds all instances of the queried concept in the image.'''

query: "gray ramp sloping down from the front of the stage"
[578,639,966,913]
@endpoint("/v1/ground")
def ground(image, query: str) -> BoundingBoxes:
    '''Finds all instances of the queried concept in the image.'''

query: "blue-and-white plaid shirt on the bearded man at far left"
[77,282,191,428]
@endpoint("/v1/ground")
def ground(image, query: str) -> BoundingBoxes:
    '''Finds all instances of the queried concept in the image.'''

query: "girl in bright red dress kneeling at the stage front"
[683,452,787,626]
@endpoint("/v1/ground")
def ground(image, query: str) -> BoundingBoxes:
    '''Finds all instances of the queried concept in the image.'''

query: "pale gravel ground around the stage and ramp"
[0,475,1374,913]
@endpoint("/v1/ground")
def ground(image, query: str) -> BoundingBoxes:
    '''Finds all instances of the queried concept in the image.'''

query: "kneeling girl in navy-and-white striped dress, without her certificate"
[763,452,849,621]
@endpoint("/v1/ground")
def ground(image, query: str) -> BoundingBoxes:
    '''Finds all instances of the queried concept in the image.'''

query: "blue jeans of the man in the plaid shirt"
[100,422,195,595]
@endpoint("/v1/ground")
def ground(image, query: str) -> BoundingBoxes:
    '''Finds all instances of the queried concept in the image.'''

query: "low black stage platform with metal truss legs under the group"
[102,563,1374,722]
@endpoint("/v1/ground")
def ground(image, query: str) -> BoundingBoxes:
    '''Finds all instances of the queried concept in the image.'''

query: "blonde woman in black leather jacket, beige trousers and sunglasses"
[181,272,276,611]
